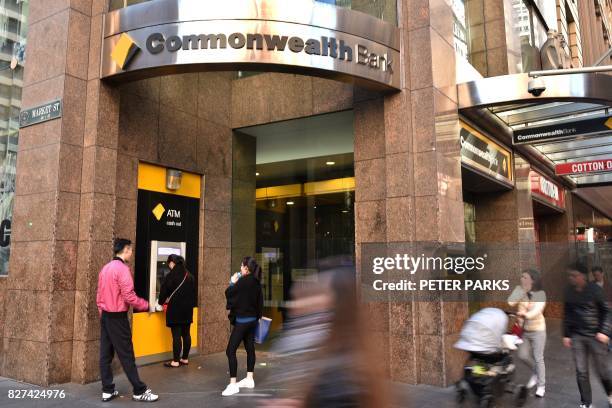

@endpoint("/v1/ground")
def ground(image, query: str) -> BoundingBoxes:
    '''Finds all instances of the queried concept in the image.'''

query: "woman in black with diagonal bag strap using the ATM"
[159,254,196,368]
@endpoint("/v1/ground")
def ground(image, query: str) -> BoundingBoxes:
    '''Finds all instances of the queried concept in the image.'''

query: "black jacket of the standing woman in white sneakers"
[225,274,263,324]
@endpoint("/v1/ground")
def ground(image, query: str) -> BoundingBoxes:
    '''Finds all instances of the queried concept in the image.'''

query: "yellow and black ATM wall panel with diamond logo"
[132,163,201,364]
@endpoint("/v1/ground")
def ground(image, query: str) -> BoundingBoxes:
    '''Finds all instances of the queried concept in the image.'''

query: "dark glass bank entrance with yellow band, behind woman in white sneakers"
[232,111,355,325]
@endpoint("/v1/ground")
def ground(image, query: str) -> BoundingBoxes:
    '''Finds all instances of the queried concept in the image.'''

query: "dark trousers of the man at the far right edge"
[572,334,612,406]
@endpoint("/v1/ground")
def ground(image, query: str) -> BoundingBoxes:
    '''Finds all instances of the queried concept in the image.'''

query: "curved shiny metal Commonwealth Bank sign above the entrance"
[101,0,401,90]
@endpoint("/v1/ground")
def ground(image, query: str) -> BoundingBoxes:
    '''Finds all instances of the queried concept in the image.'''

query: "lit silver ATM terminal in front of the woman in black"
[149,240,187,312]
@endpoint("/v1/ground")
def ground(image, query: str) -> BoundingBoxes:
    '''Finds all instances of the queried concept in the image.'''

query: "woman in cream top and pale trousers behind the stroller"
[508,269,546,398]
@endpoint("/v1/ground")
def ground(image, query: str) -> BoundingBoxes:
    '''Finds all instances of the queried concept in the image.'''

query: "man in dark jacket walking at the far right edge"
[563,263,612,408]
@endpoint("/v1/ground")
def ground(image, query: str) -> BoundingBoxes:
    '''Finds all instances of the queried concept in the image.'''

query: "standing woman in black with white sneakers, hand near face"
[221,256,263,397]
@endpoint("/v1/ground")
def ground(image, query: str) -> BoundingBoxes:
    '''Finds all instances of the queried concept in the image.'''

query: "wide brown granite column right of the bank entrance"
[355,0,467,386]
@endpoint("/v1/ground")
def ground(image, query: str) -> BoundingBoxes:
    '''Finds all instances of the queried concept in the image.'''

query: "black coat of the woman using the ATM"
[159,267,197,327]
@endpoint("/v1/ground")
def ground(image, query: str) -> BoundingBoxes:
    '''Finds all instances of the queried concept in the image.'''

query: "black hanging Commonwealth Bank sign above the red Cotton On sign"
[512,116,612,145]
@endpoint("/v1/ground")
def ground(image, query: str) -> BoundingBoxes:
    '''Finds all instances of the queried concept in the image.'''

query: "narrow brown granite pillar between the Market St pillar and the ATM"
[70,1,122,383]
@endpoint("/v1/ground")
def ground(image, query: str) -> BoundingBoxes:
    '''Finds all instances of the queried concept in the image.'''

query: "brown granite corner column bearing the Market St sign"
[1,0,99,385]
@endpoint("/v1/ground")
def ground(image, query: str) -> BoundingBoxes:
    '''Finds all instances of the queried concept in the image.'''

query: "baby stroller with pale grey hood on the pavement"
[455,308,527,408]
